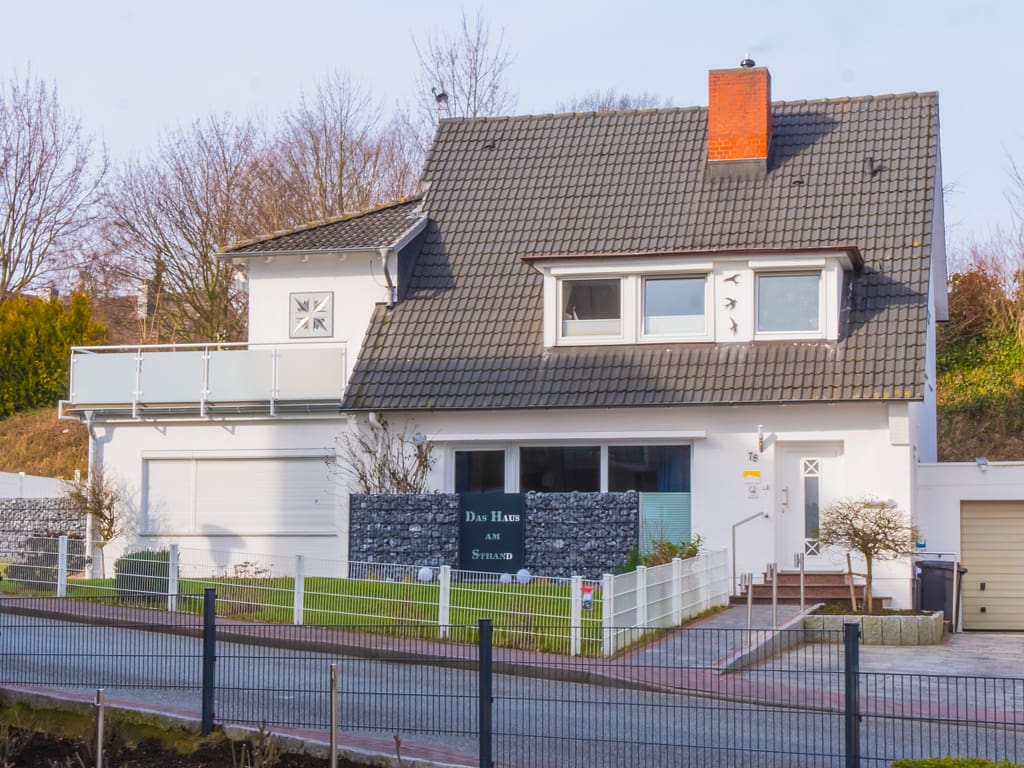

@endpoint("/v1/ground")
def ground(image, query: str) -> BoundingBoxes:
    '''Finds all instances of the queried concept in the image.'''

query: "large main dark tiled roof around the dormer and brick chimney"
[345,94,939,410]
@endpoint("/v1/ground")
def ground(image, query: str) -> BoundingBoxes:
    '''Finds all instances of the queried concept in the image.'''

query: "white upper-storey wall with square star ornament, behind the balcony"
[248,251,393,373]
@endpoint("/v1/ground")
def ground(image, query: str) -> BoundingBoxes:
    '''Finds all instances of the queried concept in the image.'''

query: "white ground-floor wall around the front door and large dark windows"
[378,403,912,605]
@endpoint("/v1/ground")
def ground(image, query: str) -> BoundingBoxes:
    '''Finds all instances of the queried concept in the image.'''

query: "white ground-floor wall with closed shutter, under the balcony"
[93,416,348,571]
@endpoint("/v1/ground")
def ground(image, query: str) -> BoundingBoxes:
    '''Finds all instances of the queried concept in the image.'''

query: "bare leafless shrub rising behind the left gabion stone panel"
[338,418,436,494]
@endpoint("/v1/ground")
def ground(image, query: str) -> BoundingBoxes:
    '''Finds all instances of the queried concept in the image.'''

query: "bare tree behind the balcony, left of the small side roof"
[109,117,270,341]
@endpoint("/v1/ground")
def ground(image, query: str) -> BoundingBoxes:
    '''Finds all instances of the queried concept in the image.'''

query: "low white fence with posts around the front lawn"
[0,537,729,655]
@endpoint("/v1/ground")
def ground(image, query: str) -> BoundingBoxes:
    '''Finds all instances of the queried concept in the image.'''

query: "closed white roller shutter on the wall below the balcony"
[143,456,337,536]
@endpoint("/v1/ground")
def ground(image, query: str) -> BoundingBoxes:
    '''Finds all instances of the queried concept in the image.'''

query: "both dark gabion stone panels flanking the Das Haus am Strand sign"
[349,492,640,579]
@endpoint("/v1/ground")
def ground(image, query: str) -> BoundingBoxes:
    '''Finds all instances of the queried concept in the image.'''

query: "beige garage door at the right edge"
[961,502,1024,630]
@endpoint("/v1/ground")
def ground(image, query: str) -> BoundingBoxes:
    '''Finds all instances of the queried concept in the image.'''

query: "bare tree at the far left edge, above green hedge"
[0,70,106,301]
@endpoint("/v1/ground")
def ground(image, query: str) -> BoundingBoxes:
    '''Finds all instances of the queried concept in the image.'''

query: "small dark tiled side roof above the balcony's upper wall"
[222,197,422,254]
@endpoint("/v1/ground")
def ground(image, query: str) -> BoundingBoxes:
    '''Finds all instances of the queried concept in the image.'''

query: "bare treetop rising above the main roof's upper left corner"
[412,12,516,151]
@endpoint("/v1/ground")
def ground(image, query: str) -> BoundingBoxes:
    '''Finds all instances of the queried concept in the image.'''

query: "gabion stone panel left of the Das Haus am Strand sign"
[348,494,459,566]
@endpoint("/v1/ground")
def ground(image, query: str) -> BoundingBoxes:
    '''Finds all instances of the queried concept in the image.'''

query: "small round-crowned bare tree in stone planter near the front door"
[818,496,918,613]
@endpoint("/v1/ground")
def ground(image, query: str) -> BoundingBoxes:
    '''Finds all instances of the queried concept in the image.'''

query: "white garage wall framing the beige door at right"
[915,462,1024,556]
